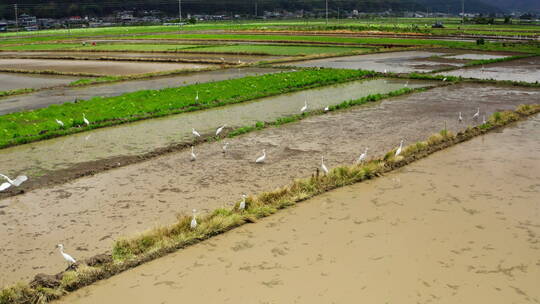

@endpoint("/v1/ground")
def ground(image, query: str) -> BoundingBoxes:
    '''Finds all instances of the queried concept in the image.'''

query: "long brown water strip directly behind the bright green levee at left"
[0,68,281,115]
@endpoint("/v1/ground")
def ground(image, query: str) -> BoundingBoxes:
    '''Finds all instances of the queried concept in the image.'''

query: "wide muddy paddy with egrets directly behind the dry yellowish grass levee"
[0,83,540,285]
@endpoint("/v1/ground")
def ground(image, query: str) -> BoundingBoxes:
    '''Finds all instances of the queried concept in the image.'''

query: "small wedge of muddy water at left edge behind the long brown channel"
[0,73,80,91]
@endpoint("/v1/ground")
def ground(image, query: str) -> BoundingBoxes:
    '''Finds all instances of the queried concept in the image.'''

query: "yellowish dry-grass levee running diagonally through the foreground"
[0,104,540,304]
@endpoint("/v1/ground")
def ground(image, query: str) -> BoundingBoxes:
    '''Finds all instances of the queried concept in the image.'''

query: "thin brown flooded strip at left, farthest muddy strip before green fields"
[0,52,284,63]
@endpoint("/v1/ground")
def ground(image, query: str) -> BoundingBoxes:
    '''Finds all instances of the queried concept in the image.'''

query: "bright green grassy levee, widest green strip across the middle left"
[0,69,375,148]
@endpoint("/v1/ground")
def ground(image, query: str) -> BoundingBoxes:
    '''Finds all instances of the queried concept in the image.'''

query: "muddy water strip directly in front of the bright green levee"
[0,79,433,180]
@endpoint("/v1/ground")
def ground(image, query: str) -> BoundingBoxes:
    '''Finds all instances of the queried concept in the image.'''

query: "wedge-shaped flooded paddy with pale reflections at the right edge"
[440,56,540,82]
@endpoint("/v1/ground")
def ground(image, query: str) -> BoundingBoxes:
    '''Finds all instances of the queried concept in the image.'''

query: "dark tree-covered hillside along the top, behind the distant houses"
[0,0,501,19]
